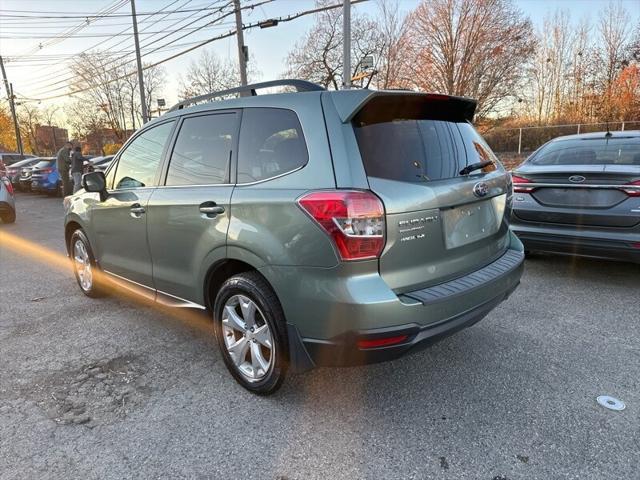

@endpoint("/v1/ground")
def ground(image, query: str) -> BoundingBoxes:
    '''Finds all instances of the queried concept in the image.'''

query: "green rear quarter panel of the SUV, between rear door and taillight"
[227,94,338,268]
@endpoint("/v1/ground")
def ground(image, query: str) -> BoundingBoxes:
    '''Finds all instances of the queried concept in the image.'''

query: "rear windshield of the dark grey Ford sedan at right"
[530,137,640,165]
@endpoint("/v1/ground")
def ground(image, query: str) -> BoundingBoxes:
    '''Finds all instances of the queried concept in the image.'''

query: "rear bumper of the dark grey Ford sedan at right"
[511,222,640,263]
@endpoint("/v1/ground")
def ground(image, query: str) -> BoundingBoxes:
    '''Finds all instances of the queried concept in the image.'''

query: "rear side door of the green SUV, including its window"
[148,110,240,303]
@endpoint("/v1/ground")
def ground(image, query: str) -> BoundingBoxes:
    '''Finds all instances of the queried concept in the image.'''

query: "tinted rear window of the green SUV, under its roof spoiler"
[353,95,499,182]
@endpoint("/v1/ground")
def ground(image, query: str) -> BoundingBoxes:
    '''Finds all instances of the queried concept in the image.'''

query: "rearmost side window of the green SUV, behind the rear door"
[238,108,309,183]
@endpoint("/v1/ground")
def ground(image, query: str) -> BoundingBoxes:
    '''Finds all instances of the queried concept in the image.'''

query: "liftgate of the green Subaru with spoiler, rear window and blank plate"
[352,93,510,293]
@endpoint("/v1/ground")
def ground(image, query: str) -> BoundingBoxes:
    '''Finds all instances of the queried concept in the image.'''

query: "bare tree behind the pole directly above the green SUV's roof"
[284,0,385,90]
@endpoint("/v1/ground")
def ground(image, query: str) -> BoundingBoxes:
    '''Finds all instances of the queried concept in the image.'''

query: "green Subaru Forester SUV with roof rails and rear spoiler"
[65,80,524,393]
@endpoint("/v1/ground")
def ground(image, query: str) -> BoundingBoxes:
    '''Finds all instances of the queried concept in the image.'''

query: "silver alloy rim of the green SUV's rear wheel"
[222,295,275,382]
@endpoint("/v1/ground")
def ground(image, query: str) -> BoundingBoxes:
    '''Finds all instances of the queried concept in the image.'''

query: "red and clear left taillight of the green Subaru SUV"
[298,190,385,260]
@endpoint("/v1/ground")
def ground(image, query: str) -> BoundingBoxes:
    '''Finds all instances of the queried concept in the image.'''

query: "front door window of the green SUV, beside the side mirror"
[107,122,175,189]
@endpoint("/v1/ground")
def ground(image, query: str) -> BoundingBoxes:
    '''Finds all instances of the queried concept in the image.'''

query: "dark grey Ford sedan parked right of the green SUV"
[511,131,640,263]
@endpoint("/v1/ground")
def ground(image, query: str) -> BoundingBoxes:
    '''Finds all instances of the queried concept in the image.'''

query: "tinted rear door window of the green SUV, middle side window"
[166,113,237,185]
